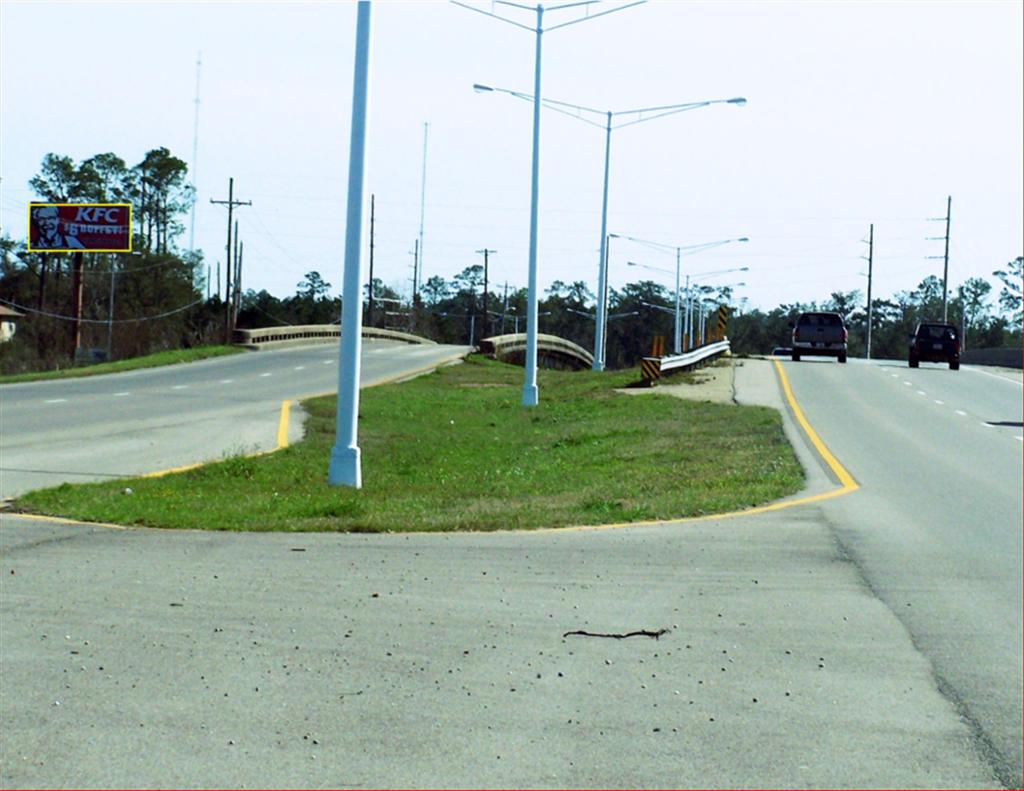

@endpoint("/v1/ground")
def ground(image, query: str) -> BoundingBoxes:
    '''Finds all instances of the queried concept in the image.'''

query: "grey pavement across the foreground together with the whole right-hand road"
[0,361,1021,788]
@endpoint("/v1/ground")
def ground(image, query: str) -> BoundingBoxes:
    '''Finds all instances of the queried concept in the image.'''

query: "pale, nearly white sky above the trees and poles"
[0,0,1024,308]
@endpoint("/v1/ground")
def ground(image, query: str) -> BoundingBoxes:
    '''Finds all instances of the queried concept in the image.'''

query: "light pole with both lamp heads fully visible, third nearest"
[473,84,746,371]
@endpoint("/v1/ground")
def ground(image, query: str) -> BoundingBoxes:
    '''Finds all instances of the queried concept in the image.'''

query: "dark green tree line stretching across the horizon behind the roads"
[0,148,1022,374]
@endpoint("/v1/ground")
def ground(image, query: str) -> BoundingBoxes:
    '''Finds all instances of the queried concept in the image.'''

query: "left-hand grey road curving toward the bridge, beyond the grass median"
[0,340,469,499]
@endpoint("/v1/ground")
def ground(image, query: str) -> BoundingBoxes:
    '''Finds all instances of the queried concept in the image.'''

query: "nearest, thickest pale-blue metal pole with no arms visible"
[328,0,371,489]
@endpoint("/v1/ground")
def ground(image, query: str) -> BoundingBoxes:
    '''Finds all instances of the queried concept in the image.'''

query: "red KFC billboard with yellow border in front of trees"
[29,203,131,253]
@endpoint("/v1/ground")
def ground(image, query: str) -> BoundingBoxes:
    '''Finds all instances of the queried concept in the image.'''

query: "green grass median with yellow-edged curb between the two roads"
[14,357,804,532]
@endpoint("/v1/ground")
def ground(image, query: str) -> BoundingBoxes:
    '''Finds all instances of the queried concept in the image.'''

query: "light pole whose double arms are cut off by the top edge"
[452,0,646,407]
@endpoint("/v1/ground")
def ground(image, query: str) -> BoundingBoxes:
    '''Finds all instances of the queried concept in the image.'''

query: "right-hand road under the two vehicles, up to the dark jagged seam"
[783,360,1024,787]
